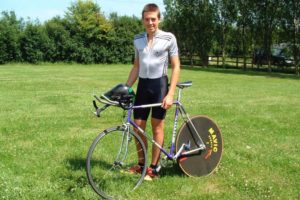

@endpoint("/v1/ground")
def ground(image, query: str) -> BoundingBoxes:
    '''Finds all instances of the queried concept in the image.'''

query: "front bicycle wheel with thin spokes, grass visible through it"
[86,127,147,199]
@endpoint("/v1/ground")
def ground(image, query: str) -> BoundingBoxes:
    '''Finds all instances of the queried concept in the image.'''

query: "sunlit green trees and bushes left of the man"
[0,0,143,64]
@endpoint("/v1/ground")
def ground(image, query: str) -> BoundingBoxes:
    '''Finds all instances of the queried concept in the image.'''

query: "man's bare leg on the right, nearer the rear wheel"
[151,118,164,165]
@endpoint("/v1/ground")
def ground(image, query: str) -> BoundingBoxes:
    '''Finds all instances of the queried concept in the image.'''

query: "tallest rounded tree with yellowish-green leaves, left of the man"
[66,0,112,63]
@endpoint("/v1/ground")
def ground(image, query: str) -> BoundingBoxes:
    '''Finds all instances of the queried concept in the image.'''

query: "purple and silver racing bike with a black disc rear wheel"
[86,81,223,199]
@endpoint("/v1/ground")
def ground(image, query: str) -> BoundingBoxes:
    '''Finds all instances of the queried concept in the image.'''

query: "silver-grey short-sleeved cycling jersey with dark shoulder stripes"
[134,30,178,79]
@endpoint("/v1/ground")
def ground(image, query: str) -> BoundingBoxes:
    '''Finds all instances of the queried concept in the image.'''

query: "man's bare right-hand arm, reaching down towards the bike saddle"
[162,56,180,109]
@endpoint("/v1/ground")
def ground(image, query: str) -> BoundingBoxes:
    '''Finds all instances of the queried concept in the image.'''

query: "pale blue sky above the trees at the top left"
[0,0,164,22]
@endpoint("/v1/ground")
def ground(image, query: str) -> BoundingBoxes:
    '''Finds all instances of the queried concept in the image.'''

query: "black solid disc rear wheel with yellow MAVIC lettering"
[176,115,223,176]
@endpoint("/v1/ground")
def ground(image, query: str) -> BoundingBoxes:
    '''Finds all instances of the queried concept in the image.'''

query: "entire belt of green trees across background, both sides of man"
[0,0,300,72]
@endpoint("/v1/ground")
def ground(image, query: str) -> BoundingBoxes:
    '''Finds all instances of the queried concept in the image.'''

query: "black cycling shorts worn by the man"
[133,76,168,120]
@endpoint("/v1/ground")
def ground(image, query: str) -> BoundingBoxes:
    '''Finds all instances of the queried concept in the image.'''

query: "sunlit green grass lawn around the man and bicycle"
[0,64,300,199]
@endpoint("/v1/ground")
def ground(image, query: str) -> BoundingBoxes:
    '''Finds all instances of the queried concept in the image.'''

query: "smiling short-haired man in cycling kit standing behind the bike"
[127,4,180,180]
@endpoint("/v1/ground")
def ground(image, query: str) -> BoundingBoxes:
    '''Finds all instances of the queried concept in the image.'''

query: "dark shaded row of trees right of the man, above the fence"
[164,0,300,72]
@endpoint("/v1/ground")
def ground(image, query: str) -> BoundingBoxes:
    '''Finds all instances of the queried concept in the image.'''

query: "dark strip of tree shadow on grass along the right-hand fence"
[181,65,300,80]
